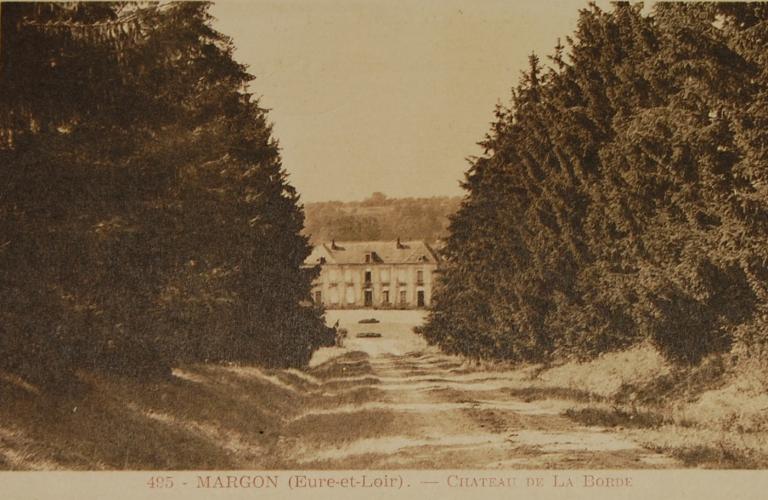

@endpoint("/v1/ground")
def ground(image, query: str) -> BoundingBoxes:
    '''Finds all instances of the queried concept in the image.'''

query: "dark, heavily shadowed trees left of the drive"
[0,2,332,388]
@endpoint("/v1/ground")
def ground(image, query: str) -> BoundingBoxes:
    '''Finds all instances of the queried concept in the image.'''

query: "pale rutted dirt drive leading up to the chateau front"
[274,311,675,469]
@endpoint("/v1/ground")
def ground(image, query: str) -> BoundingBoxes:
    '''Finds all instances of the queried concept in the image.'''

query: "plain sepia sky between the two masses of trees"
[211,0,607,202]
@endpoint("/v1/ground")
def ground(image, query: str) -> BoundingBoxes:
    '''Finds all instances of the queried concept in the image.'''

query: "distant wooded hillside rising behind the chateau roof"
[304,192,461,243]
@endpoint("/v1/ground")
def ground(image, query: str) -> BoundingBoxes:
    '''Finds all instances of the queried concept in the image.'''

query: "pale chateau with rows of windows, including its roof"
[305,240,438,309]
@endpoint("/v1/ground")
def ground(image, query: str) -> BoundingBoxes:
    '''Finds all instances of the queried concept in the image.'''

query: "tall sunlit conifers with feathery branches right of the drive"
[424,2,768,364]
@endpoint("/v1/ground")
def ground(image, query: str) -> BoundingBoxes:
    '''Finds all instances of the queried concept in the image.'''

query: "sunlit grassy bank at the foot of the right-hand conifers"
[509,345,768,469]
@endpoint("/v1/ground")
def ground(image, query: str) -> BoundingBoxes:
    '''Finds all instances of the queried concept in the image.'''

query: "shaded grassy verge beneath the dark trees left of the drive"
[0,356,364,470]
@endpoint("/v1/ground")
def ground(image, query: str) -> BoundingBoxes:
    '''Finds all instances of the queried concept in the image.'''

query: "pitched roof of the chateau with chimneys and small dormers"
[304,241,438,265]
